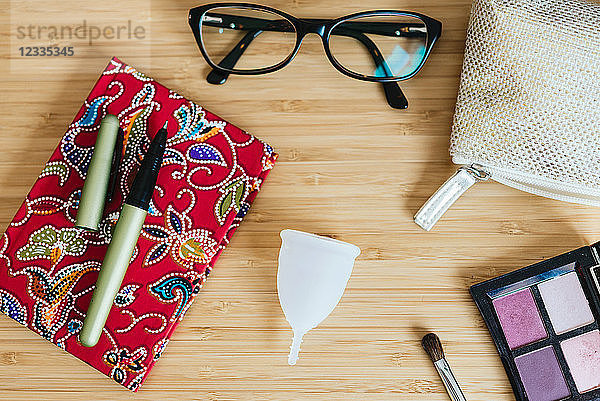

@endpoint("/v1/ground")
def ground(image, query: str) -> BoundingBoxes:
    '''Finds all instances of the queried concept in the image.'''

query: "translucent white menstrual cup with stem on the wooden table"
[277,230,360,365]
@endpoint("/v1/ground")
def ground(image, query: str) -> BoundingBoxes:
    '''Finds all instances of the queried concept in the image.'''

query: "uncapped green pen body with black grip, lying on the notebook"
[79,123,167,347]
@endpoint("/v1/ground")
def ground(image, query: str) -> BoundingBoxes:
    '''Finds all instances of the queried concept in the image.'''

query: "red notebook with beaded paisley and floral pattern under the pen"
[0,58,277,391]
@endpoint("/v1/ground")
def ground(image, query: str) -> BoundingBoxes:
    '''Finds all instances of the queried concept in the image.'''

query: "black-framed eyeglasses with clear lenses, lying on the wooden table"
[189,3,442,109]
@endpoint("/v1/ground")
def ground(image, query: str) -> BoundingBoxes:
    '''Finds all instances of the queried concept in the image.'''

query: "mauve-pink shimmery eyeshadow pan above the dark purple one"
[492,288,548,349]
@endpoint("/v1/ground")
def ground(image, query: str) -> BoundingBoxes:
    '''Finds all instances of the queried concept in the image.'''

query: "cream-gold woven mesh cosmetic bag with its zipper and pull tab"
[415,0,600,230]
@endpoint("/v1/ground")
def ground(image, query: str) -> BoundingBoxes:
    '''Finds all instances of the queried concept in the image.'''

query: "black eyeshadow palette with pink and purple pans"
[471,243,600,401]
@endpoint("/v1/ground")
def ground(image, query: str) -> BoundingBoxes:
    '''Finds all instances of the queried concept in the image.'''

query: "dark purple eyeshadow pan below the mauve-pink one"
[515,347,571,401]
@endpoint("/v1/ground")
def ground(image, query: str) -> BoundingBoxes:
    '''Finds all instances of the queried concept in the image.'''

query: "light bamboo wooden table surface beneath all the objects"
[0,0,600,401]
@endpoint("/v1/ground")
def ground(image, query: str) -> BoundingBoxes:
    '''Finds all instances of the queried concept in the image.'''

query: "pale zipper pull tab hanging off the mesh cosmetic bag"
[415,165,490,231]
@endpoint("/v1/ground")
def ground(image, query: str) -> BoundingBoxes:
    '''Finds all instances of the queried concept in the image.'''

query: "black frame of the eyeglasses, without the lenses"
[188,3,442,109]
